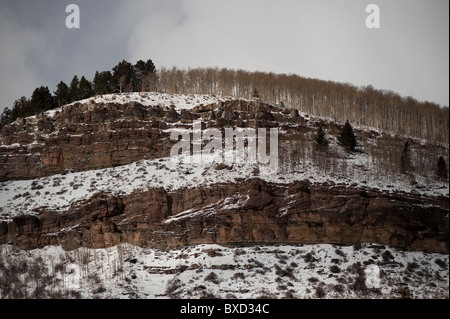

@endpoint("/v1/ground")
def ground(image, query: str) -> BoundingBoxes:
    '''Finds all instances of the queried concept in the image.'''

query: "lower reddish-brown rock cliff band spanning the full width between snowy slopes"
[0,179,449,253]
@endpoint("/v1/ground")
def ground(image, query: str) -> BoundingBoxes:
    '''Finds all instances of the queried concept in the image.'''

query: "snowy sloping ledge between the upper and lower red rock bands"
[0,144,449,221]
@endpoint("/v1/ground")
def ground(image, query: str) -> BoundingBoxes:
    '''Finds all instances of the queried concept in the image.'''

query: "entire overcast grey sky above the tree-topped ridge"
[0,0,449,111]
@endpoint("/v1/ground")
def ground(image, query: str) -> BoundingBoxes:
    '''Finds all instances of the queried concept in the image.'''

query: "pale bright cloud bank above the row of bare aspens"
[128,0,449,105]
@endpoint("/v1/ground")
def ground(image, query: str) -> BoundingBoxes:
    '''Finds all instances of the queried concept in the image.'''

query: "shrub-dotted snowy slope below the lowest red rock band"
[0,245,449,299]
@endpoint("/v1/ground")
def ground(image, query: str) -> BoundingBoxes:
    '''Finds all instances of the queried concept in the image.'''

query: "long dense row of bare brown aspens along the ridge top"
[154,67,449,144]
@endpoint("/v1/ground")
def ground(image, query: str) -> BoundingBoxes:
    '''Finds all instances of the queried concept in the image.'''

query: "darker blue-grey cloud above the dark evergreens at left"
[0,0,133,110]
